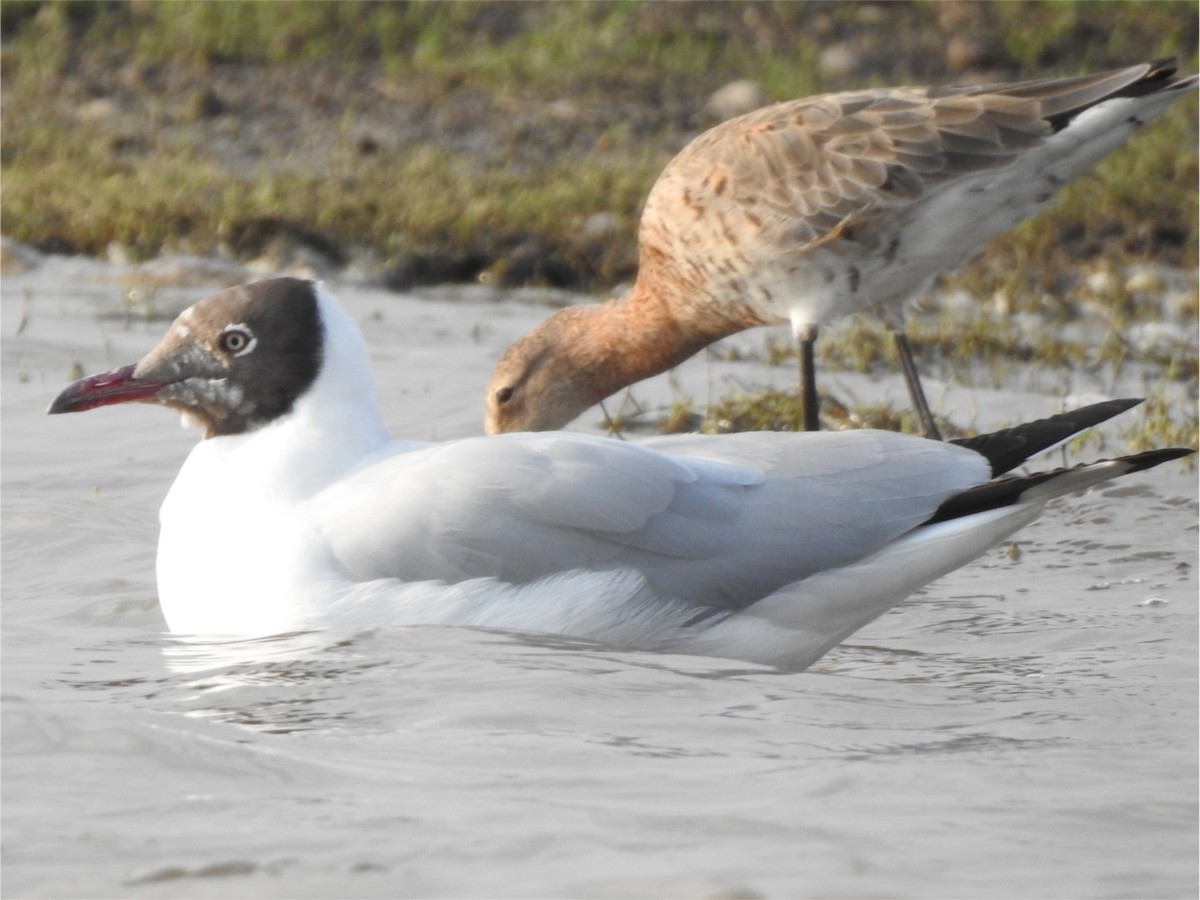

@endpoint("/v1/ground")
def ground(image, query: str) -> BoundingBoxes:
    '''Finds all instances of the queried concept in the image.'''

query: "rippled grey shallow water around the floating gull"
[7,263,1200,898]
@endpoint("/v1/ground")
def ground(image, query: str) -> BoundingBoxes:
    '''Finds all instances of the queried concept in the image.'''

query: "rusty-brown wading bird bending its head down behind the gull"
[484,61,1196,437]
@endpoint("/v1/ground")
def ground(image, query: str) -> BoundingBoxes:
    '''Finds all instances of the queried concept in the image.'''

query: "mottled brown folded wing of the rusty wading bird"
[662,64,1175,245]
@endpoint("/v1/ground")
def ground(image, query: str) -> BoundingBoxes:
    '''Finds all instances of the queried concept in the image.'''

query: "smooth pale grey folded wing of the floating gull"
[314,432,988,607]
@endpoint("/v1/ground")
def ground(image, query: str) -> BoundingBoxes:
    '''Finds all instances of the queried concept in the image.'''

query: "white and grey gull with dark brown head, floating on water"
[49,278,1190,668]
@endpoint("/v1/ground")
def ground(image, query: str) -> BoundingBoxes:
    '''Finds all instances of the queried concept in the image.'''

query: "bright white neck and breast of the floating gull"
[157,289,389,632]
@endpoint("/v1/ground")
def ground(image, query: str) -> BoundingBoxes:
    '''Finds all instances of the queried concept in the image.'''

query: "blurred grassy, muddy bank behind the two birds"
[0,0,1196,292]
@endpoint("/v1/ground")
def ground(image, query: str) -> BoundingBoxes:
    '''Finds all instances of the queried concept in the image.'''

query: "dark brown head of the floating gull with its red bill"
[47,278,324,438]
